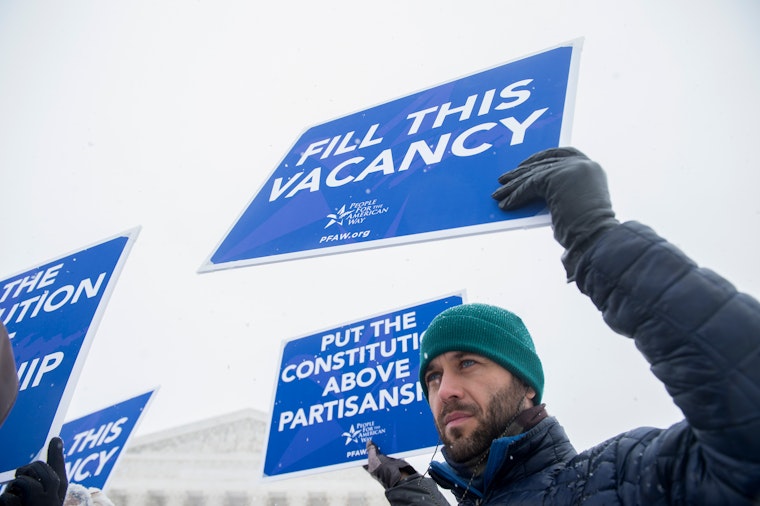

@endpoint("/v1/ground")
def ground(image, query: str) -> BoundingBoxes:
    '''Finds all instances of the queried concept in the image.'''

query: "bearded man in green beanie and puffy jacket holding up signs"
[365,148,760,505]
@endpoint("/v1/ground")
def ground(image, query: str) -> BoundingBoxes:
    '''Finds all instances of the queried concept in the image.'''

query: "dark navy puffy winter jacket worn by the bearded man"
[386,222,760,505]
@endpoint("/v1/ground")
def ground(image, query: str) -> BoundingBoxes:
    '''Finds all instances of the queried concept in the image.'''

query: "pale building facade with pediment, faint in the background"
[105,410,388,506]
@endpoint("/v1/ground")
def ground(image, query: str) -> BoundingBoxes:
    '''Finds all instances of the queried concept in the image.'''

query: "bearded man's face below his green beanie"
[425,351,536,463]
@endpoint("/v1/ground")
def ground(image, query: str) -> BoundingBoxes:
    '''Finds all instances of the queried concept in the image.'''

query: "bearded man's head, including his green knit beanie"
[420,304,546,462]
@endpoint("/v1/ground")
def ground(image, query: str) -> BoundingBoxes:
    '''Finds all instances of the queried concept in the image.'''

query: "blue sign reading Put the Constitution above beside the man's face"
[262,294,464,479]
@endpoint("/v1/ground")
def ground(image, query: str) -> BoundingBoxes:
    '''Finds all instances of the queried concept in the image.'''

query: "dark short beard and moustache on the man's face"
[436,383,526,465]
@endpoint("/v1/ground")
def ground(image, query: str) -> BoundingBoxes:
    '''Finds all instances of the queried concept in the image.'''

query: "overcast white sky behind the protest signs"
[0,0,760,472]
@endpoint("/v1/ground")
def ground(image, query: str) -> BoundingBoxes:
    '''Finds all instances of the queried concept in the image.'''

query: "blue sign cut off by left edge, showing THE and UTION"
[0,229,138,482]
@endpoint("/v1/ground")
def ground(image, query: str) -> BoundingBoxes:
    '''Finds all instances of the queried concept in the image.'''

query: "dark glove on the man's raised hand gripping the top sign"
[492,147,619,281]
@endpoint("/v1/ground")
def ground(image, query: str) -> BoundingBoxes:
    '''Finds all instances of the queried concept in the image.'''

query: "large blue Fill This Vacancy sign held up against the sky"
[199,40,581,272]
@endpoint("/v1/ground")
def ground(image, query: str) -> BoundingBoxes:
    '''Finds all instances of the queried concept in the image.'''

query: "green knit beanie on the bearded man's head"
[420,304,544,404]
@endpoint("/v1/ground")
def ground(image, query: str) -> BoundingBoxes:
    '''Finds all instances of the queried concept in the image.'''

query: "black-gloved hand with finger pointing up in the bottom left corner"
[2,437,69,506]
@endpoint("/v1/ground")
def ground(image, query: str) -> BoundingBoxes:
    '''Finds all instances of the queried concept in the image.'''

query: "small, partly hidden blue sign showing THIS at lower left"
[61,390,155,490]
